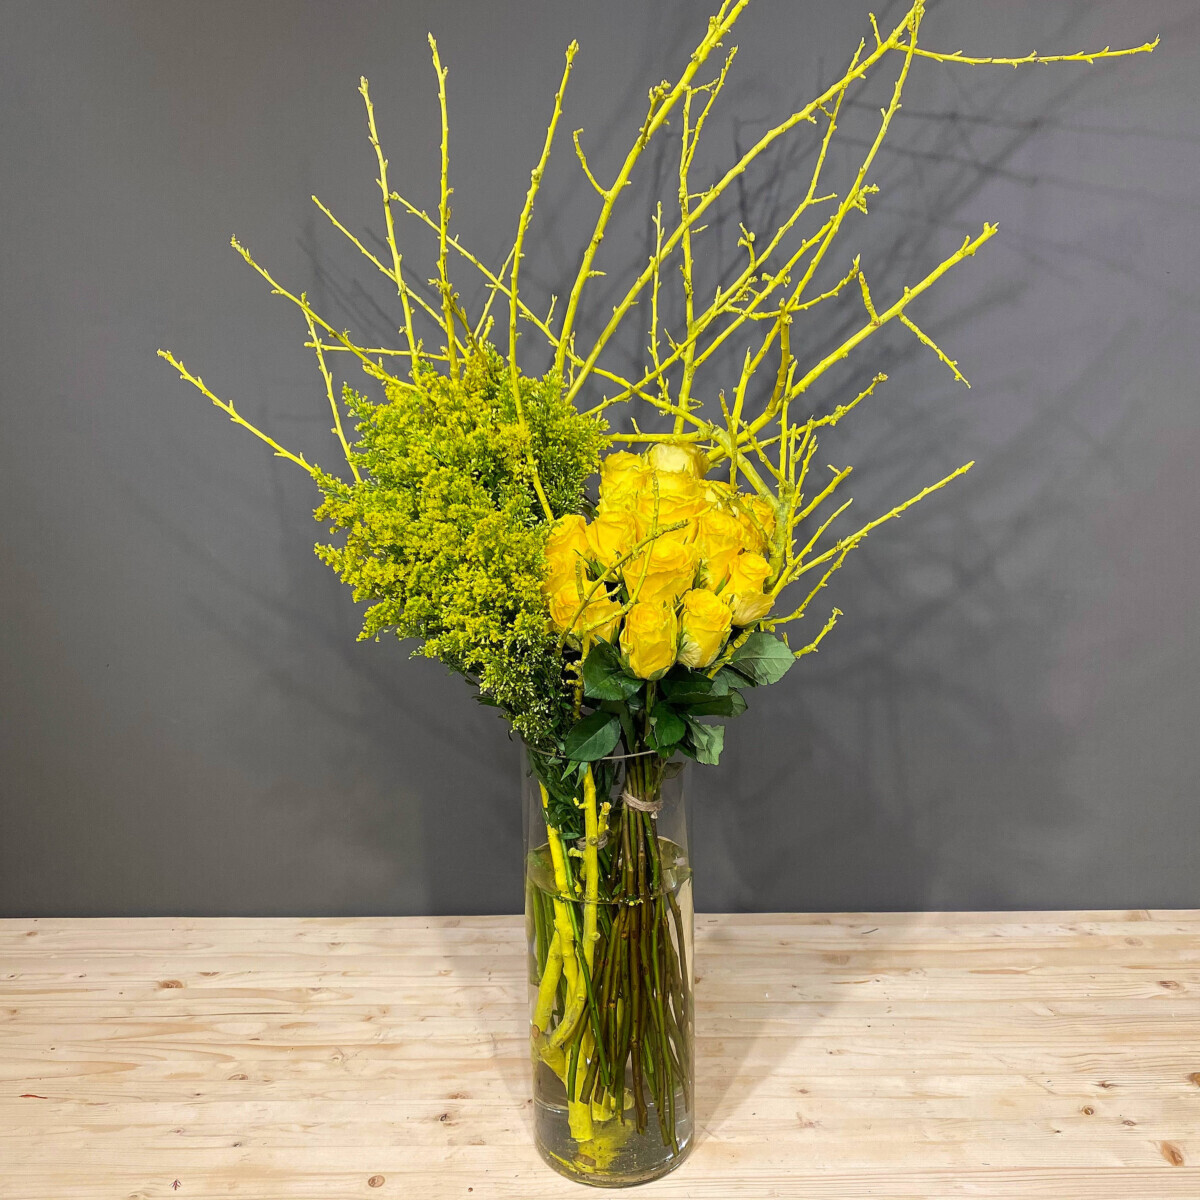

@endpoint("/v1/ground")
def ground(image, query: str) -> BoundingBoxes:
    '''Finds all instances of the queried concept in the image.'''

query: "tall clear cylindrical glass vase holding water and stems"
[524,749,695,1187]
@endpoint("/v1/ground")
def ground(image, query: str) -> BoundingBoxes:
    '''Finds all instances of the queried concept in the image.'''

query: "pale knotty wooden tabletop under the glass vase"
[0,910,1200,1200]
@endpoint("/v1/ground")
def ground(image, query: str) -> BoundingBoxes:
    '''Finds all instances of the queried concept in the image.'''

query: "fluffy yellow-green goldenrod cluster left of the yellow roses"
[316,344,606,744]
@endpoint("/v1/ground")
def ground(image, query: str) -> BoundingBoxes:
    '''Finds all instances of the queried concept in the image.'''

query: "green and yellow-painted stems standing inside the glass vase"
[529,754,692,1153]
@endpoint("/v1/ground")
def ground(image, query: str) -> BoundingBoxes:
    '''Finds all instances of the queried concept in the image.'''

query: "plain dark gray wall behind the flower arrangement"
[0,0,1200,916]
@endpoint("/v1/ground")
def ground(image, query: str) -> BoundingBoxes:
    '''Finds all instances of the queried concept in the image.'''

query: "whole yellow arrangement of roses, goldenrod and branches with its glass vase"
[160,0,1154,1183]
